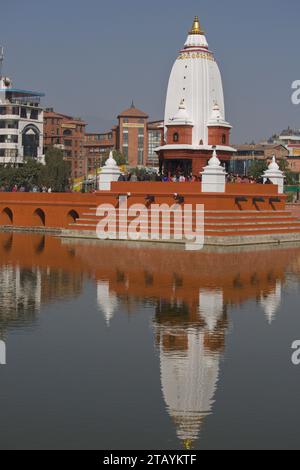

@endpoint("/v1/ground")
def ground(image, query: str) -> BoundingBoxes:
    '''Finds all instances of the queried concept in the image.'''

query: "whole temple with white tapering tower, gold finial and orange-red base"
[157,16,234,171]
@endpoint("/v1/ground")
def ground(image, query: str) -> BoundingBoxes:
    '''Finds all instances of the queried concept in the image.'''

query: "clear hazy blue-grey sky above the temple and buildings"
[0,0,300,142]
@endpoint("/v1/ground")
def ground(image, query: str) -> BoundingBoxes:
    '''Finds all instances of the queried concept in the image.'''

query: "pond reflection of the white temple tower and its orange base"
[155,290,227,448]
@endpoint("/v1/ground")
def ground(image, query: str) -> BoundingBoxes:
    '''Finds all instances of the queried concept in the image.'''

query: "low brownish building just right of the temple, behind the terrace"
[230,143,289,175]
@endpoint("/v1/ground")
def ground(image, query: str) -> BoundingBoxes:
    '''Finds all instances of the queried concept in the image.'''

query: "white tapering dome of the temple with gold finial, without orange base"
[165,17,231,146]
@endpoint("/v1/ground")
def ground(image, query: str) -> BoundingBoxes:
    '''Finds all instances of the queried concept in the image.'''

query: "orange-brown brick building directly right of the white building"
[44,108,87,178]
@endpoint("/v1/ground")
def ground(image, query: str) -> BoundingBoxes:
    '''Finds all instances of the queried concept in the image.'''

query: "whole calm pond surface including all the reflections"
[0,233,300,449]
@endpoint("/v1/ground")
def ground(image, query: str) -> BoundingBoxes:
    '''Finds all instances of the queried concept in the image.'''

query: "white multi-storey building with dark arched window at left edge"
[0,48,44,166]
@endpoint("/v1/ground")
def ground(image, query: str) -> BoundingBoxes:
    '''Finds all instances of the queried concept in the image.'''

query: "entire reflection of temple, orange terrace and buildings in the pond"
[0,233,300,448]
